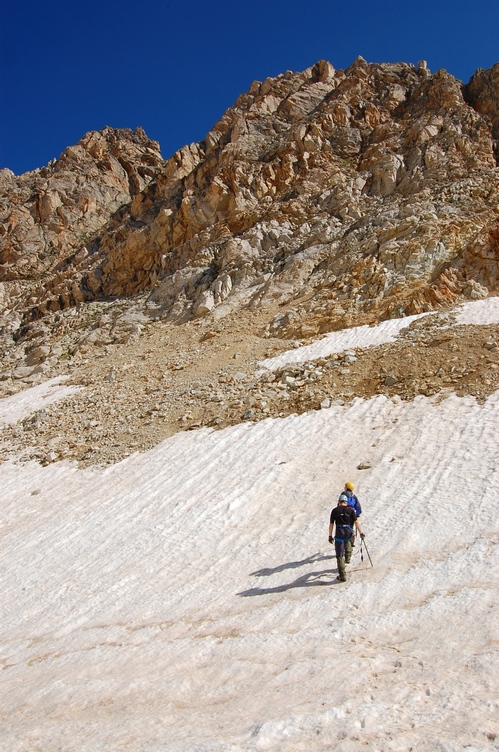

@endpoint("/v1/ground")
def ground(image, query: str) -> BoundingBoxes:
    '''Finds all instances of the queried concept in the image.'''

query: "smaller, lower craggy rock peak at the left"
[0,128,163,300]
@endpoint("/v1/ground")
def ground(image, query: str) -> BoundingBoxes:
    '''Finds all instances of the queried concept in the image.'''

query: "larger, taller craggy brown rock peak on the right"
[92,58,499,336]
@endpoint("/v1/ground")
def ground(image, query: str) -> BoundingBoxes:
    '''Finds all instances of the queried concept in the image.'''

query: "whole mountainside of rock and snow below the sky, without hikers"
[0,58,499,752]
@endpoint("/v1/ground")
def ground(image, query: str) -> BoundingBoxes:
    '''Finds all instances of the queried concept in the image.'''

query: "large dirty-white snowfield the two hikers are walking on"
[0,300,499,752]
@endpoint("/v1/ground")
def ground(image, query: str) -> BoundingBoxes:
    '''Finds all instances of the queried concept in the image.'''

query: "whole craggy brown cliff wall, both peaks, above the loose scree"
[0,58,499,366]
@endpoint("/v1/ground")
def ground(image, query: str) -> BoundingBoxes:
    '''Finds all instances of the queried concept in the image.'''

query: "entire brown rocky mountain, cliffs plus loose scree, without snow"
[0,58,499,461]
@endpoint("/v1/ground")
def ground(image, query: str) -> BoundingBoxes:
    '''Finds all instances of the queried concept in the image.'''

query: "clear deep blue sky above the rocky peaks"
[0,0,499,174]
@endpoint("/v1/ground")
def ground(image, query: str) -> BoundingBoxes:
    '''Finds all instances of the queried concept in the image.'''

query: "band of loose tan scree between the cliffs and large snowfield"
[0,298,499,465]
